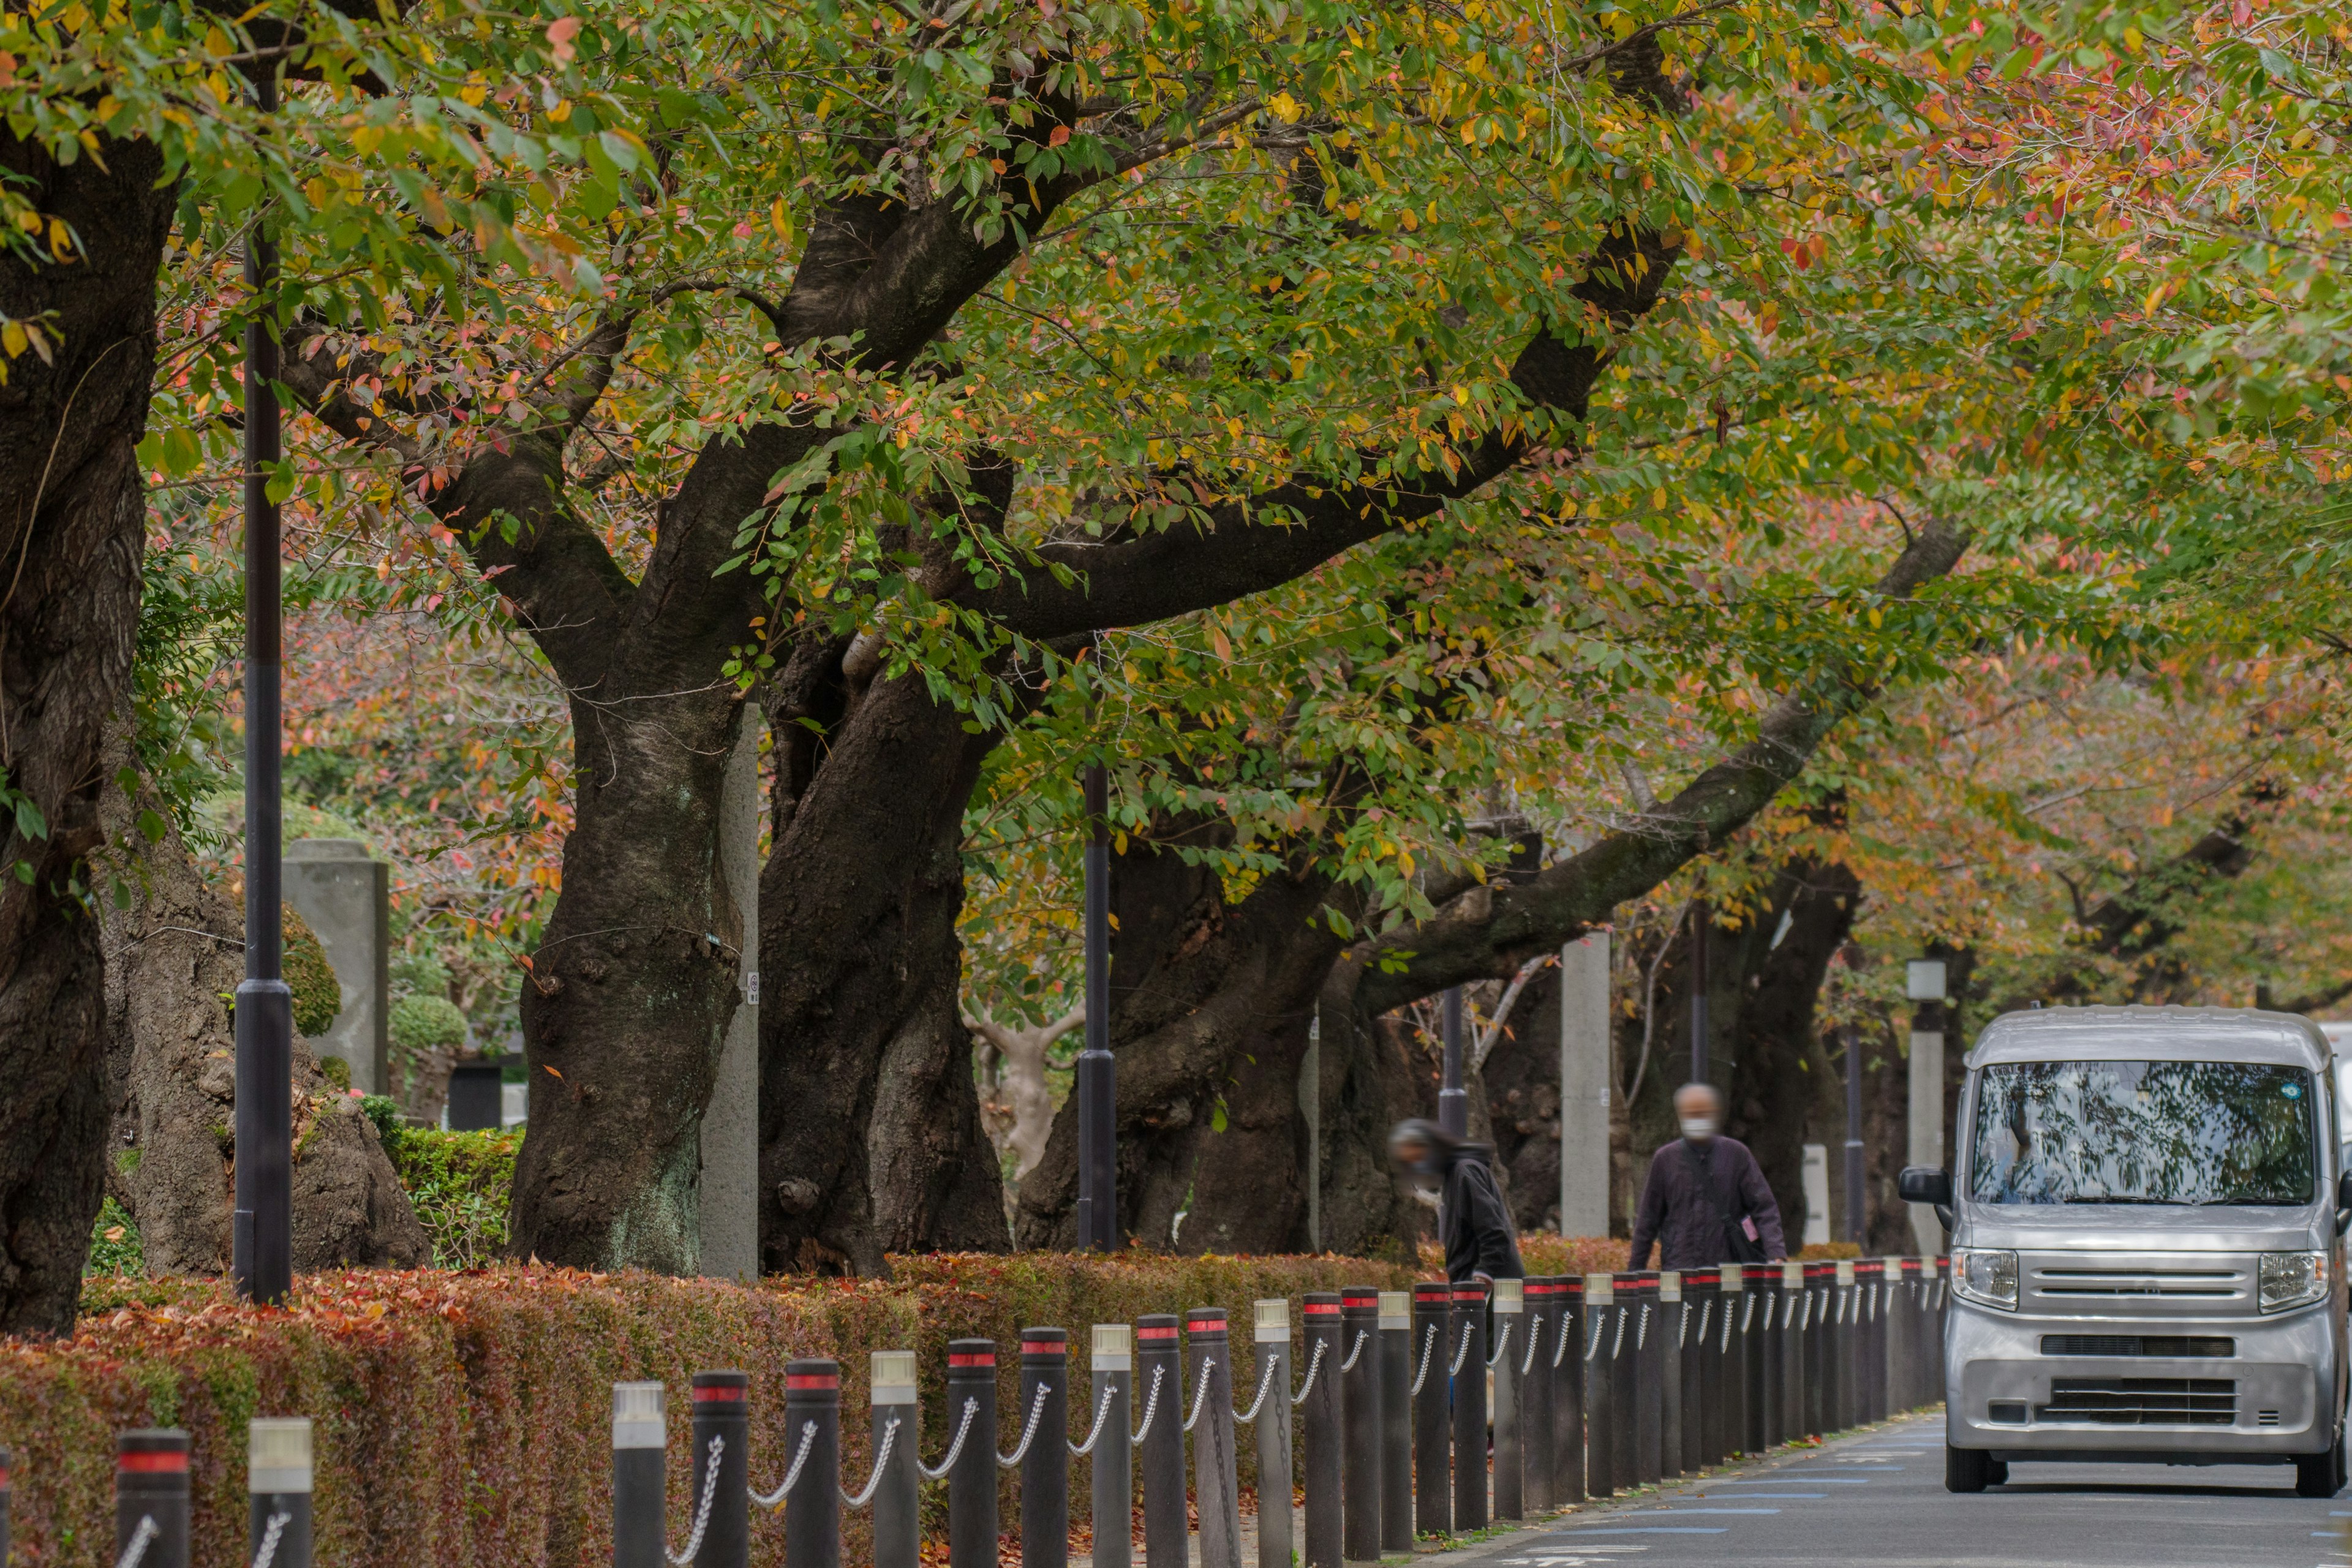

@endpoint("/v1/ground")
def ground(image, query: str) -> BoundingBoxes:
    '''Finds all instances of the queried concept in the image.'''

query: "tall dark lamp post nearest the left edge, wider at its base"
[230,70,294,1302]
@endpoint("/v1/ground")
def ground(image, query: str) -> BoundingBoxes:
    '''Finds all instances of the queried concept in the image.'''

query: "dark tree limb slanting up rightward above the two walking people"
[1357,522,1969,1013]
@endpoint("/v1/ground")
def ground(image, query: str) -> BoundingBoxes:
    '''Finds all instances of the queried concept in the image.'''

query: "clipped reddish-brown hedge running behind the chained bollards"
[0,1253,1411,1568]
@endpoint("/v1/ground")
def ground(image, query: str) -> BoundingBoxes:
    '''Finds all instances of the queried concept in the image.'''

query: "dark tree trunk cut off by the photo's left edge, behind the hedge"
[0,127,174,1333]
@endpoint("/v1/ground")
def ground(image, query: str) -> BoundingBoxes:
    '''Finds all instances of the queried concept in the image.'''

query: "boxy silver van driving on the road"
[1901,1006,2352,1498]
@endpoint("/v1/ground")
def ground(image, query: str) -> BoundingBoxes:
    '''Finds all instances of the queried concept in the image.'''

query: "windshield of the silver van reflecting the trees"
[1969,1063,2316,1204]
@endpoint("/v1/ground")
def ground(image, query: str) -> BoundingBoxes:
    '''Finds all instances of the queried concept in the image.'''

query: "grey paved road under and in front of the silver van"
[1463,1415,2352,1568]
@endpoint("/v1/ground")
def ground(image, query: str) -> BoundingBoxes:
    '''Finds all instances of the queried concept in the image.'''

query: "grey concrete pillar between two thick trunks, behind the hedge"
[701,719,767,1281]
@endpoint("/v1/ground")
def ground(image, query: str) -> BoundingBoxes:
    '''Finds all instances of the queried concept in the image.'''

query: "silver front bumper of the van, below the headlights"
[1945,1298,2338,1462]
